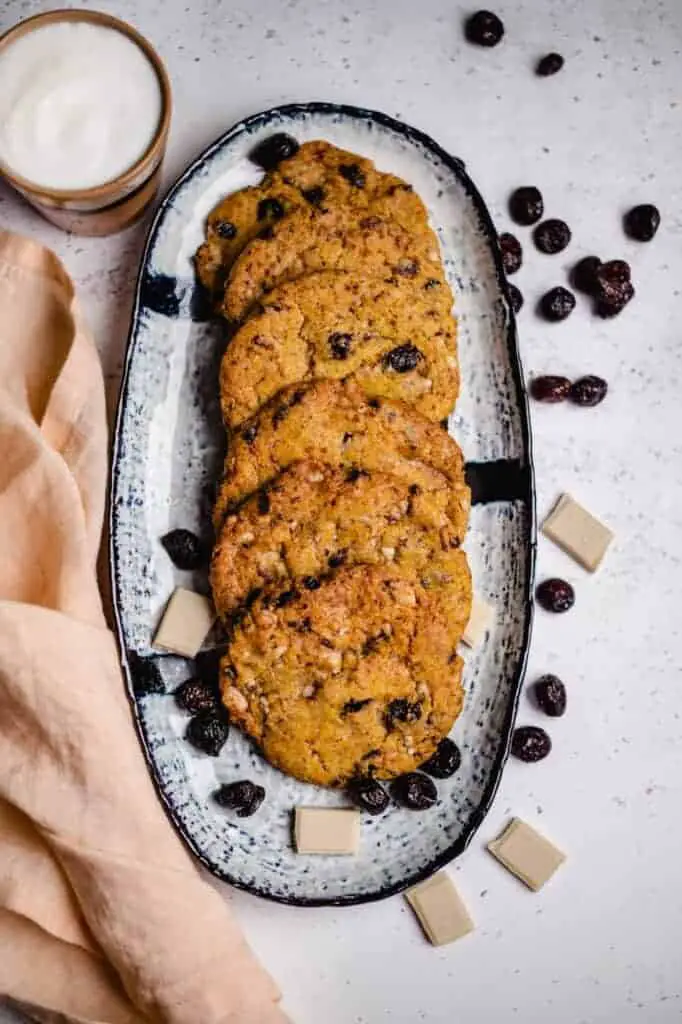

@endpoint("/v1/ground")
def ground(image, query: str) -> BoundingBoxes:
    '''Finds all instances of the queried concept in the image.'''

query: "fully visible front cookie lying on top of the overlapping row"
[220,565,462,785]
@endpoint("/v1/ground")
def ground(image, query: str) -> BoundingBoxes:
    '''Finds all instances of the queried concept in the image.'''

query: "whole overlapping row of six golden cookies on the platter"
[197,134,471,785]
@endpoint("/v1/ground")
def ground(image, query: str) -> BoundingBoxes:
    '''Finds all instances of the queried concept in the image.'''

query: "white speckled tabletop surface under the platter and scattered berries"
[0,0,682,1024]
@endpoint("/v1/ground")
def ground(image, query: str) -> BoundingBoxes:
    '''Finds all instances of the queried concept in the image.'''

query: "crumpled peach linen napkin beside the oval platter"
[0,231,286,1024]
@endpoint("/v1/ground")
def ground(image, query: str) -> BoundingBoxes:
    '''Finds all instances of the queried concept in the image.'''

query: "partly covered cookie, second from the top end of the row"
[221,187,447,321]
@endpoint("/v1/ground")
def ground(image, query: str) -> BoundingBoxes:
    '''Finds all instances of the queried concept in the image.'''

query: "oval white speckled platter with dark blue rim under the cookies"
[111,103,536,905]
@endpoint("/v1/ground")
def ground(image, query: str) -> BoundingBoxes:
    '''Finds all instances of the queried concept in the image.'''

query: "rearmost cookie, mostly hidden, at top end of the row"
[196,139,406,293]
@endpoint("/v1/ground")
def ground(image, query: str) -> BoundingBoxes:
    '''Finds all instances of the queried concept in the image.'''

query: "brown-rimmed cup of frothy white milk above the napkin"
[0,10,171,234]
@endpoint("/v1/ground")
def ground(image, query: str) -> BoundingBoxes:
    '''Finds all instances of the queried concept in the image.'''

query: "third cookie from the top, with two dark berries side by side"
[220,271,459,428]
